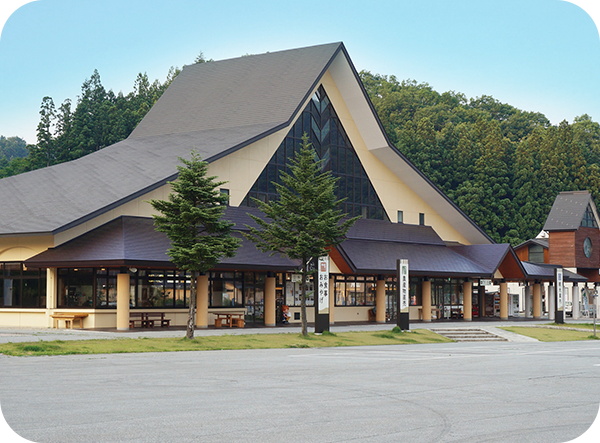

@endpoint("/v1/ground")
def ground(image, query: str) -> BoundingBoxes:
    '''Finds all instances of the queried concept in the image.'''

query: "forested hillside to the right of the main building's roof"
[360,71,600,245]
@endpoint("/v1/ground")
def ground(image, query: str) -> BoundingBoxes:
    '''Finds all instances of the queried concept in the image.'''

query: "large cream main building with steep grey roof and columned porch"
[0,43,540,329]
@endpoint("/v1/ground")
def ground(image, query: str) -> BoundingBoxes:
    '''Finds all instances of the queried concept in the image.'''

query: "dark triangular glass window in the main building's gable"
[241,86,389,220]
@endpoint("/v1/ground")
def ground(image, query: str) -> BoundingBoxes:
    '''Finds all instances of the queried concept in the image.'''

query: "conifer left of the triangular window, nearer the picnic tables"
[150,152,239,339]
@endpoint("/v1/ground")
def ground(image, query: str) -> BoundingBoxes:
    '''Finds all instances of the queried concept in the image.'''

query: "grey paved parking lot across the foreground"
[0,341,600,443]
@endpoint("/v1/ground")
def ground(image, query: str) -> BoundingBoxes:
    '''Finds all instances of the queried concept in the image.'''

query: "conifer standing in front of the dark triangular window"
[244,134,360,335]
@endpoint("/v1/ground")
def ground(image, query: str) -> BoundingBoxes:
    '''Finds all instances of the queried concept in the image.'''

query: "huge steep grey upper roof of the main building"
[0,43,493,243]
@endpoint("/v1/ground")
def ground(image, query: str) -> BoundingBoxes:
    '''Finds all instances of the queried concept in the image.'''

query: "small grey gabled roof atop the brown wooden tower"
[544,191,598,231]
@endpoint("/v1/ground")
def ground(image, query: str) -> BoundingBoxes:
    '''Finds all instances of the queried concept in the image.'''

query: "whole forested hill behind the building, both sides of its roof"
[0,61,600,245]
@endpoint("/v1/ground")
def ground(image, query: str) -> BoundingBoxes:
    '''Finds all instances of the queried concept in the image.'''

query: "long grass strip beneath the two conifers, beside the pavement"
[0,329,451,356]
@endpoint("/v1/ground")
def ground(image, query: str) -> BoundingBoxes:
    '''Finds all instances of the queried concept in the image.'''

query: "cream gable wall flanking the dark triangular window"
[54,53,489,250]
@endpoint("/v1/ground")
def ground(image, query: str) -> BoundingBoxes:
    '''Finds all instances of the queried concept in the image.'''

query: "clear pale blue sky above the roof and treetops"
[0,0,600,143]
